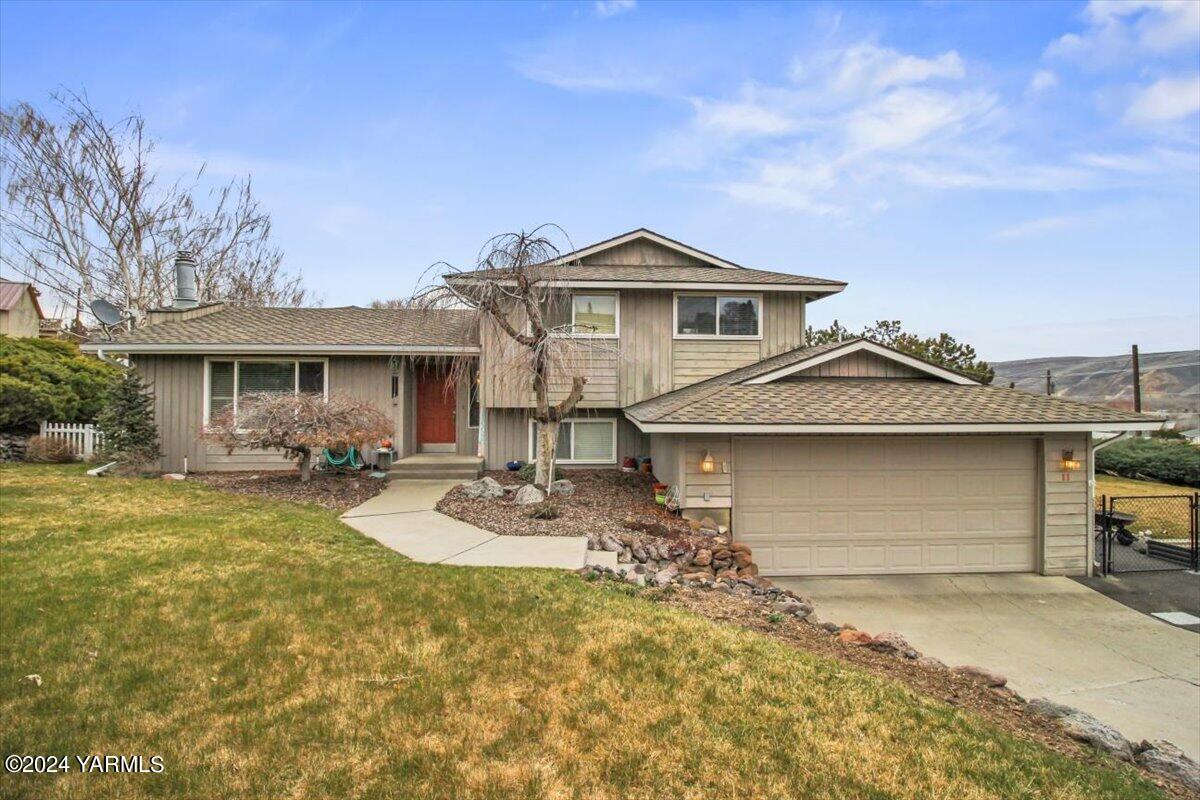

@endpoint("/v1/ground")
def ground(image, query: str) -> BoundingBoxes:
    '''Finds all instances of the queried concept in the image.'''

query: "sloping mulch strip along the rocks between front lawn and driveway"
[644,587,1193,798]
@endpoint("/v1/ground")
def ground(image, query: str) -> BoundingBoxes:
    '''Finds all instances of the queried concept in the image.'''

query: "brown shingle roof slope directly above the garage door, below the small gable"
[637,378,1151,425]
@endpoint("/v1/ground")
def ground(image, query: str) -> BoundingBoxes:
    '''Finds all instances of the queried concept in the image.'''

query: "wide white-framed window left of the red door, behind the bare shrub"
[204,359,328,422]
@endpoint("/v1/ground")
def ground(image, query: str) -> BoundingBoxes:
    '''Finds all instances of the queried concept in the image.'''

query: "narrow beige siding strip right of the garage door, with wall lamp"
[1042,434,1092,576]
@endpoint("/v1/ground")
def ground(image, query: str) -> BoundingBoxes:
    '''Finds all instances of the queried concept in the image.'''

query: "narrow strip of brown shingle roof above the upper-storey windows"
[444,264,846,291]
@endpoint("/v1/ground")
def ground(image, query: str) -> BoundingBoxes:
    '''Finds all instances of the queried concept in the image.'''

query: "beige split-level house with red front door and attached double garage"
[77,229,1162,576]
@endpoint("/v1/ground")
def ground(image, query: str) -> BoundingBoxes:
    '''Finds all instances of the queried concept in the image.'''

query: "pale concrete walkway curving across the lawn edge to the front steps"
[342,480,588,570]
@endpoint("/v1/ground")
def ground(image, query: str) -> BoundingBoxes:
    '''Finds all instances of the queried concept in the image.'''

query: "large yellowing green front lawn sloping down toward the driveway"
[0,467,1158,799]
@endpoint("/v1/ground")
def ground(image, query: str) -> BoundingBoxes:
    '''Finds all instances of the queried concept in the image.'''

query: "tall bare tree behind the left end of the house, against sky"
[0,94,305,312]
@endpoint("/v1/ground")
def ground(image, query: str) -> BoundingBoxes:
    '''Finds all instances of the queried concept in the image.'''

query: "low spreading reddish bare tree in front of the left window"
[204,393,392,482]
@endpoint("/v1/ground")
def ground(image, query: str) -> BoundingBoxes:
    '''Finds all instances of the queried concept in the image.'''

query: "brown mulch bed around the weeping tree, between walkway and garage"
[437,469,692,539]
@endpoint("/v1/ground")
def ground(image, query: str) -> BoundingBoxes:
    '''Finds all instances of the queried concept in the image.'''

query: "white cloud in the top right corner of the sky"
[1045,0,1200,67]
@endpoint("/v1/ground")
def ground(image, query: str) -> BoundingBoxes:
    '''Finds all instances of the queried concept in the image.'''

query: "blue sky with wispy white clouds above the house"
[0,1,1200,360]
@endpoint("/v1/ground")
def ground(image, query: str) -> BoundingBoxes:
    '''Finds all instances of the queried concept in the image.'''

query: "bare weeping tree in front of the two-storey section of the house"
[412,225,612,486]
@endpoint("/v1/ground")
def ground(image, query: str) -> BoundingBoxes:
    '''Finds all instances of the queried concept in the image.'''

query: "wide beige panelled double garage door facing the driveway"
[733,437,1037,576]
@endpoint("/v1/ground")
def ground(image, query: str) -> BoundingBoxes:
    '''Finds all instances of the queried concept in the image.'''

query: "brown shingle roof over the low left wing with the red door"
[88,306,479,348]
